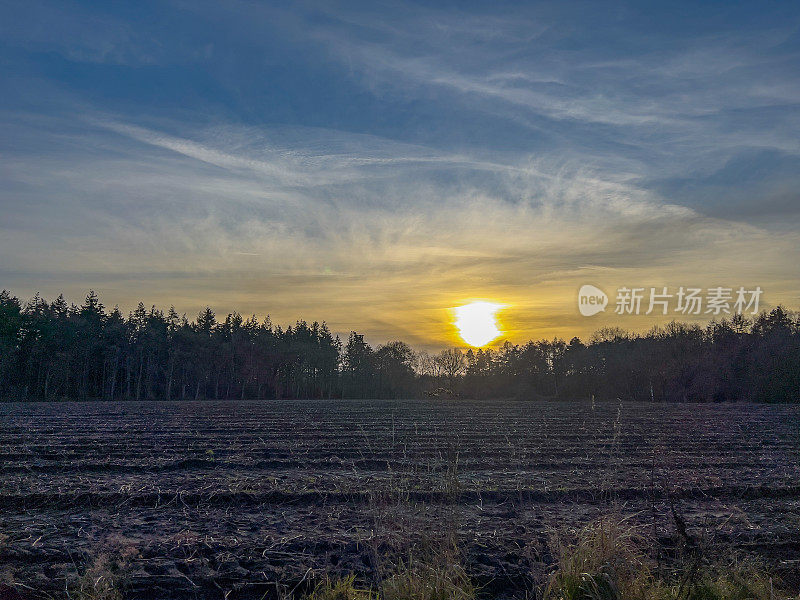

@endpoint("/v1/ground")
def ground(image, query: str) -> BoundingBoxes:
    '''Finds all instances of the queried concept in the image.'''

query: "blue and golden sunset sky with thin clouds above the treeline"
[0,0,800,348]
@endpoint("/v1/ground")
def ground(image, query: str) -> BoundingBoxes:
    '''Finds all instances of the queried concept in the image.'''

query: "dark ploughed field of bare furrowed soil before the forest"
[0,399,800,599]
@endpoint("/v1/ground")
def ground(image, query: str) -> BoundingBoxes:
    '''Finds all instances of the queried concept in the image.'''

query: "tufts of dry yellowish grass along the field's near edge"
[0,516,800,600]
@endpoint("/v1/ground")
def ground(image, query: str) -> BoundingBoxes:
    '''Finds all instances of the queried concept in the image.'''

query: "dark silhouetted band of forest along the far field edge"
[0,290,800,402]
